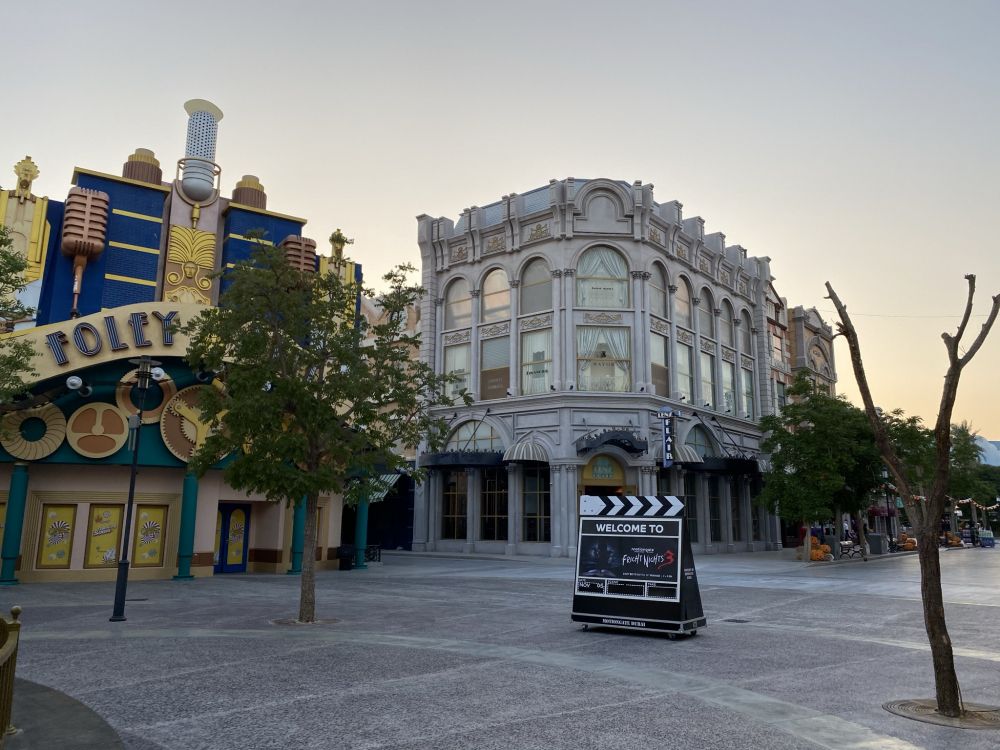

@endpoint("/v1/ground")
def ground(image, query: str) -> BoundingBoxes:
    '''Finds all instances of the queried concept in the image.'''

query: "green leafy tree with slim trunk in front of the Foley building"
[182,244,450,622]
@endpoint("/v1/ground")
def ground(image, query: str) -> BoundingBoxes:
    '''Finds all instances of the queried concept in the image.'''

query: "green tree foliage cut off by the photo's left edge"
[0,226,35,404]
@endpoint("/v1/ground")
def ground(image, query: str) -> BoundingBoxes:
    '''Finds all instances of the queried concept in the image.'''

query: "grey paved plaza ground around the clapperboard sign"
[0,549,1000,750]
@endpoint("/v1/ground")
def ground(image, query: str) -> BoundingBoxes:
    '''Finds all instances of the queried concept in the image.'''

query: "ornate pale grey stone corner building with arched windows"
[413,178,835,556]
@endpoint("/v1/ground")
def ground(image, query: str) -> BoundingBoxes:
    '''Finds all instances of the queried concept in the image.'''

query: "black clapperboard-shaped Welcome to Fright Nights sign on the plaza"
[572,495,706,634]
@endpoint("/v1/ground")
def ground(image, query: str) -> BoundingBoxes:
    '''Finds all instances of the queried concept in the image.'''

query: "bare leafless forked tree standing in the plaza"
[826,274,1000,717]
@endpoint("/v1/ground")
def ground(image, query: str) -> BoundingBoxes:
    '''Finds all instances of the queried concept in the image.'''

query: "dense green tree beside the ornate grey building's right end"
[758,373,881,561]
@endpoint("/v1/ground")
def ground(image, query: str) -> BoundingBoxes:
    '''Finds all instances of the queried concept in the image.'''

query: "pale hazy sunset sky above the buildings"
[0,0,1000,439]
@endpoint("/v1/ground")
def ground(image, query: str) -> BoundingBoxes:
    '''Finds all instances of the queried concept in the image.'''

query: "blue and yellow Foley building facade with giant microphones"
[0,100,361,584]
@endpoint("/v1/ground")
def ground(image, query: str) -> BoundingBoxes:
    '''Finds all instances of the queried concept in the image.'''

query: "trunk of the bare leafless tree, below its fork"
[917,524,962,716]
